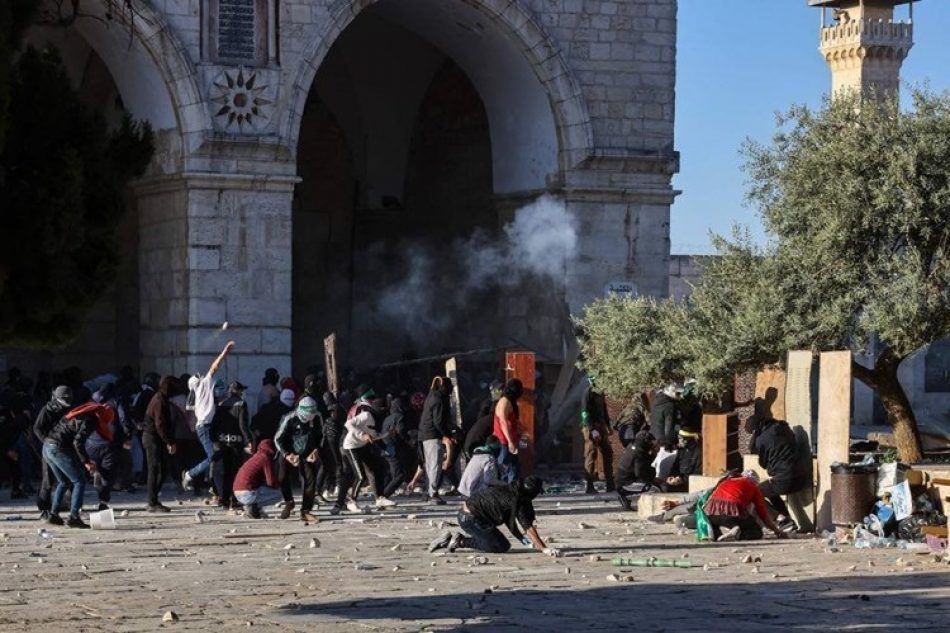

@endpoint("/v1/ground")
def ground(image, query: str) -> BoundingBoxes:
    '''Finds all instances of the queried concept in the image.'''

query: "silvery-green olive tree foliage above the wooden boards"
[578,92,950,396]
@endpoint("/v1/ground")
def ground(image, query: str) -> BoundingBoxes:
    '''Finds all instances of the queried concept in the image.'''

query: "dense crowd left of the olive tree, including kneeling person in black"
[0,342,564,553]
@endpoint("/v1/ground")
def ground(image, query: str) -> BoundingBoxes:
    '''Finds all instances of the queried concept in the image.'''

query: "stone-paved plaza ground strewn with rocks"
[0,478,950,633]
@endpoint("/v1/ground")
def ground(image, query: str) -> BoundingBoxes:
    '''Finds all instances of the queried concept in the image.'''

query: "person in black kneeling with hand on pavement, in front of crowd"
[429,477,560,556]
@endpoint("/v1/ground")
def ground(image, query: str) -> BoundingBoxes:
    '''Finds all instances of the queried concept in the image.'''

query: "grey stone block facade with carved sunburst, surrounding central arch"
[3,0,678,384]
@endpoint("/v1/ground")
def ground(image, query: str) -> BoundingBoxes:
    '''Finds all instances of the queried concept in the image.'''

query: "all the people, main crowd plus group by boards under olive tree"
[0,350,812,555]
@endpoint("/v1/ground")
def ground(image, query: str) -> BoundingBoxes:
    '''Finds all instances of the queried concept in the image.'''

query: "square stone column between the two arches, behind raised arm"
[137,173,296,396]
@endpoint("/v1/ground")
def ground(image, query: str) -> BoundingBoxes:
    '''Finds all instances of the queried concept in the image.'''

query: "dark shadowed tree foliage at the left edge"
[0,48,154,347]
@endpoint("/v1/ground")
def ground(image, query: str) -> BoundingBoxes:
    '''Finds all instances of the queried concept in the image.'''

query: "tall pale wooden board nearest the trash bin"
[816,352,852,531]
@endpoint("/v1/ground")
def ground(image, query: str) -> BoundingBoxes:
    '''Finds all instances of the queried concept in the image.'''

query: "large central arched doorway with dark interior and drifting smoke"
[291,0,589,372]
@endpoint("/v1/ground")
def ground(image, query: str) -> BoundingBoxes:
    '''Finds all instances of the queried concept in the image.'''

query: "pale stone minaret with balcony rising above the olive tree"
[808,0,914,95]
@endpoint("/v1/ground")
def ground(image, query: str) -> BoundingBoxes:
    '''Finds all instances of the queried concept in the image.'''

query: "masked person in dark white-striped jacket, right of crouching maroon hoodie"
[274,396,323,523]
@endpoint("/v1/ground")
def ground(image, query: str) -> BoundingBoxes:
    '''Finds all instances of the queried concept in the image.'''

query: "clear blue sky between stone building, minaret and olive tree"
[671,0,950,254]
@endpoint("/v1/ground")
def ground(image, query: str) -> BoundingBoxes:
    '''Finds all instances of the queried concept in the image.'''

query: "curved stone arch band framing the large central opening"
[281,0,593,193]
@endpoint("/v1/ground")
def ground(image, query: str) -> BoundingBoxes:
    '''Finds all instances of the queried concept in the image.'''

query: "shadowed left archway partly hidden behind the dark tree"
[8,7,200,375]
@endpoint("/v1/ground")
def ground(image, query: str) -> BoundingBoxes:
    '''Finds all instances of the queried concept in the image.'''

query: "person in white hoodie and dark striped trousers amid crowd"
[330,398,396,514]
